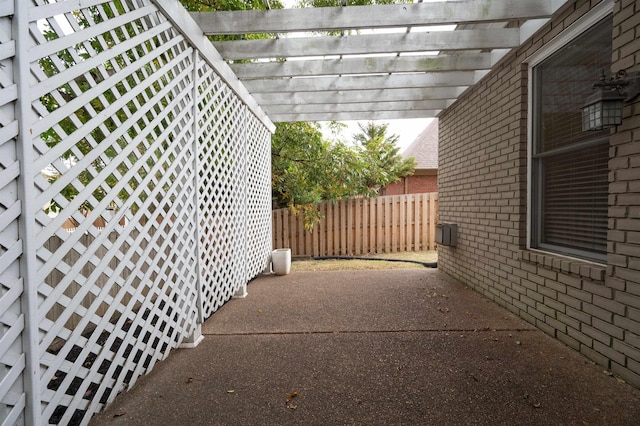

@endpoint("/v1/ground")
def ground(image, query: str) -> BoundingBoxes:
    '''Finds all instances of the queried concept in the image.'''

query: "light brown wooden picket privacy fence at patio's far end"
[272,193,438,256]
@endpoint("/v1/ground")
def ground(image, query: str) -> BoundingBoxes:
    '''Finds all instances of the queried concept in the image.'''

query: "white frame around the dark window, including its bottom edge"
[525,0,614,264]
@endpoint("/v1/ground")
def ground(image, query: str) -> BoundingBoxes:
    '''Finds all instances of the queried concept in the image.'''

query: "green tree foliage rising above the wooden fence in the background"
[272,122,415,229]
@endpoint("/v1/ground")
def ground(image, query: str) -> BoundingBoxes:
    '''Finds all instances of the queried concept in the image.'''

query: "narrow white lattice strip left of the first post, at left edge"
[0,5,25,425]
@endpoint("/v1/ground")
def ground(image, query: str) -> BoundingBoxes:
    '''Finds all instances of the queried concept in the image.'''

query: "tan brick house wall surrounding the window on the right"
[438,0,640,387]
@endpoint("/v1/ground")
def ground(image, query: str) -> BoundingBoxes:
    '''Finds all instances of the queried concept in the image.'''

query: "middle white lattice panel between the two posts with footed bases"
[197,62,247,318]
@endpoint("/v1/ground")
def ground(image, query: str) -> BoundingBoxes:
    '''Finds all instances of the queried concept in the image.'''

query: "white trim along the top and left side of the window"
[524,0,614,263]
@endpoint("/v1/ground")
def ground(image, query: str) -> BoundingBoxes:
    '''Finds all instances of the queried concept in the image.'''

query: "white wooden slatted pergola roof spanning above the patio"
[191,0,568,122]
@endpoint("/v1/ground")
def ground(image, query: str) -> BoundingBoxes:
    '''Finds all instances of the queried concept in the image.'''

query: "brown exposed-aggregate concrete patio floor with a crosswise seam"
[91,269,640,426]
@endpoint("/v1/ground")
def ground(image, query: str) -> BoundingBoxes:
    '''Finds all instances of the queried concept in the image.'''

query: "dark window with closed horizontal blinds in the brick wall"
[530,16,612,261]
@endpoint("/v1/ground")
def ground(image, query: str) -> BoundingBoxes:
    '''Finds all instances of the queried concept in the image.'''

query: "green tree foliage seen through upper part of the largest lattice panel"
[38,0,165,212]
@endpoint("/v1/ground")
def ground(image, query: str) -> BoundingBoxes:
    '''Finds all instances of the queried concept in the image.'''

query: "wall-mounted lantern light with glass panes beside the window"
[582,70,640,131]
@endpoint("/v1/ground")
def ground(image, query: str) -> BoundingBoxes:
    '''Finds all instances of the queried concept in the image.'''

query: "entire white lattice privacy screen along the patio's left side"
[0,0,273,425]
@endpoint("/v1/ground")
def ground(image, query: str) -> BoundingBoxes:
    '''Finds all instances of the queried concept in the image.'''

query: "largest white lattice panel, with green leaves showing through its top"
[30,0,197,425]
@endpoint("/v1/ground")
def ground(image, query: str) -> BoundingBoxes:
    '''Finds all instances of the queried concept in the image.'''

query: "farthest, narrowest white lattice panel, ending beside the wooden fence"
[247,114,272,280]
